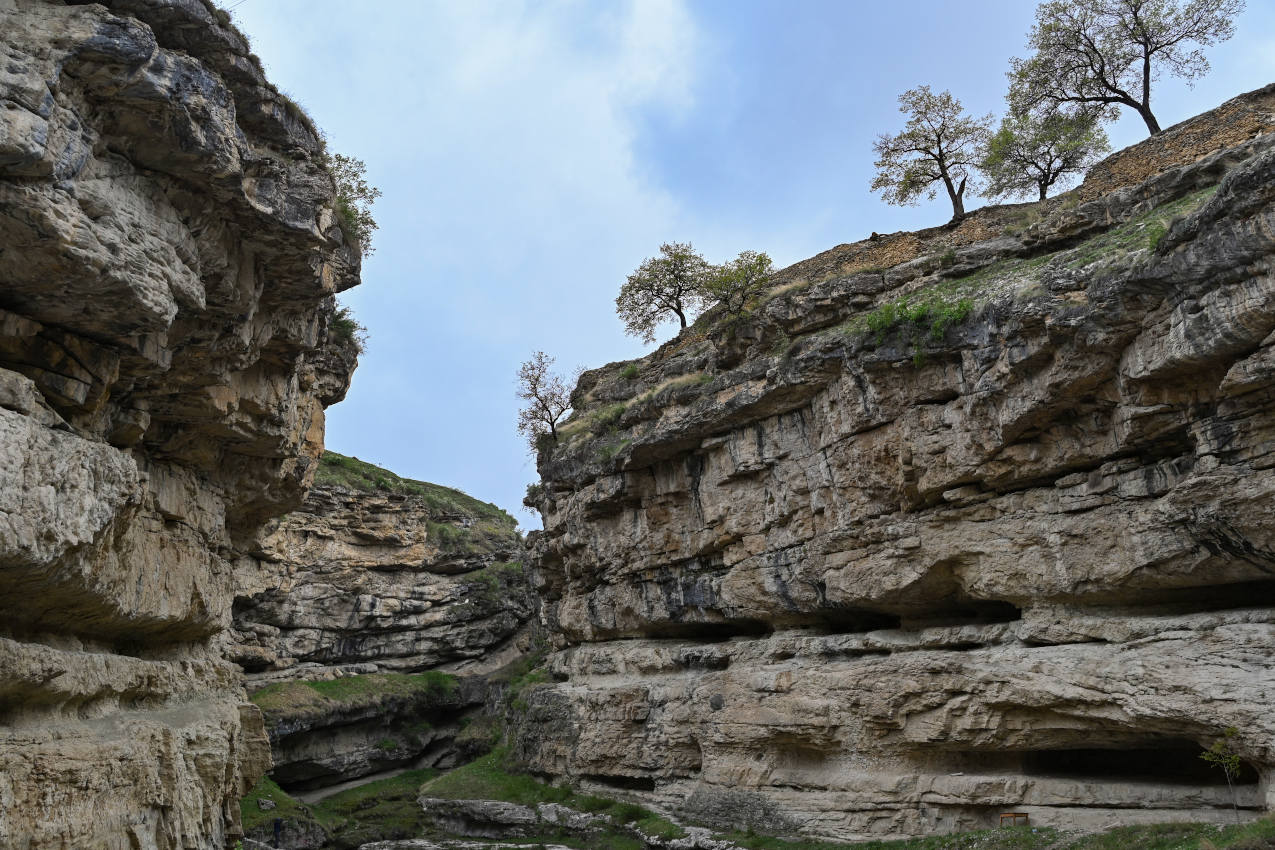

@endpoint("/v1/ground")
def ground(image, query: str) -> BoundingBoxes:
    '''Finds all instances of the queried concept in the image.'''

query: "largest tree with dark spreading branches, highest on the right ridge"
[1010,0,1244,135]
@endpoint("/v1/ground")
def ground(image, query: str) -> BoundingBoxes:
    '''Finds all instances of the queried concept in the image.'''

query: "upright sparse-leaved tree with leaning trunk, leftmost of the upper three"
[872,85,992,220]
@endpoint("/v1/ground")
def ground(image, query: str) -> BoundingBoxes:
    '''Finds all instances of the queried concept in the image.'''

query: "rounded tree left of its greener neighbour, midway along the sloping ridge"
[616,242,709,343]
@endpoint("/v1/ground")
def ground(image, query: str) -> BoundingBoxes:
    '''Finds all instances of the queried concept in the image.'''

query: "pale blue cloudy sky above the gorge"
[224,0,1275,528]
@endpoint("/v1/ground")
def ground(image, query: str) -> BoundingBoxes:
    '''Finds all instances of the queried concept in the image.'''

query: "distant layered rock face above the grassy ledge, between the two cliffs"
[233,452,533,683]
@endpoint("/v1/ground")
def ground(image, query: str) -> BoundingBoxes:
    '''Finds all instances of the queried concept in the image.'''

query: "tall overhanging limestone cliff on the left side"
[0,0,358,850]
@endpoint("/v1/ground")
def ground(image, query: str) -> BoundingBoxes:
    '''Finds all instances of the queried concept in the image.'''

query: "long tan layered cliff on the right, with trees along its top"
[518,87,1275,839]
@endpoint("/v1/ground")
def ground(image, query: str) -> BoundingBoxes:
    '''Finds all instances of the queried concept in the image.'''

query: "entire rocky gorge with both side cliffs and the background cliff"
[0,0,1275,850]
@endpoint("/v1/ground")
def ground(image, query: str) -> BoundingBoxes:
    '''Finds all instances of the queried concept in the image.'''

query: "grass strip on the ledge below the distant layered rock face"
[249,670,459,724]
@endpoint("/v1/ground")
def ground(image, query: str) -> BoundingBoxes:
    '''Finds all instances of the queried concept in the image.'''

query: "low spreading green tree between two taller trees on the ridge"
[979,110,1111,200]
